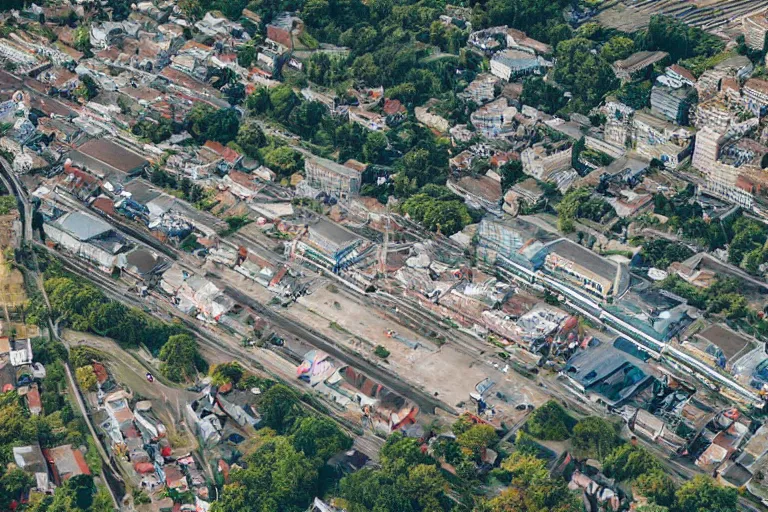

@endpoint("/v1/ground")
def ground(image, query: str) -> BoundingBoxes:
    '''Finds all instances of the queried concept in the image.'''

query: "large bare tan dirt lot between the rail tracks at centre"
[205,267,548,428]
